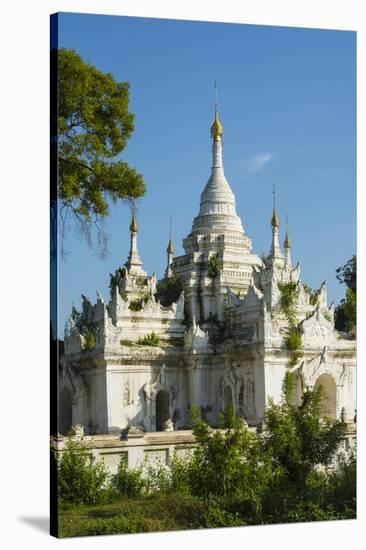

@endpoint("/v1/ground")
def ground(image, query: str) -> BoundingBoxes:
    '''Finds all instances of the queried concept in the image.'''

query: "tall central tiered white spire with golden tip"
[172,95,262,323]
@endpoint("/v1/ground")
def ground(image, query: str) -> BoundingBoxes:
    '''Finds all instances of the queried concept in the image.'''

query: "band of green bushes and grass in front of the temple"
[56,380,356,534]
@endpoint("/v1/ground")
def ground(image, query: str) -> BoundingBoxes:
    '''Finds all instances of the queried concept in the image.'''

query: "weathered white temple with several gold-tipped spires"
[59,104,356,470]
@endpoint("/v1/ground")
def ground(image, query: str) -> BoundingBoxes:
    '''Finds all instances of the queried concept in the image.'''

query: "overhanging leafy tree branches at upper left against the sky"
[53,48,145,251]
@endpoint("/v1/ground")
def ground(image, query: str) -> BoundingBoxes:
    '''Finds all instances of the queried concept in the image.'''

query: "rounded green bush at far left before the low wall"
[58,441,108,506]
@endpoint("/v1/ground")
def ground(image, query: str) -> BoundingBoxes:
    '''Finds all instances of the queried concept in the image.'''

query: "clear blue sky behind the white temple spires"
[55,14,356,333]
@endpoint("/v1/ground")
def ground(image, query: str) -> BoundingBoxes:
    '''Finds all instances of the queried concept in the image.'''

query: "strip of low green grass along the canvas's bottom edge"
[59,487,356,538]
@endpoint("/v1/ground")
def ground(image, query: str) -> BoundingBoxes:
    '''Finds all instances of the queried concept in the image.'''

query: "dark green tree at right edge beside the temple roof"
[335,255,357,332]
